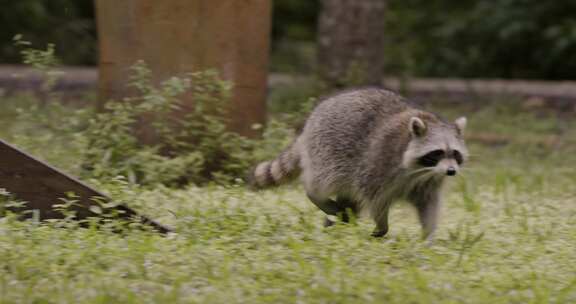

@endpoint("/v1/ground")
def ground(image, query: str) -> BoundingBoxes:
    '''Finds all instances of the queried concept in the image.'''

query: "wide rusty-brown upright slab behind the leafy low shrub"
[96,0,271,138]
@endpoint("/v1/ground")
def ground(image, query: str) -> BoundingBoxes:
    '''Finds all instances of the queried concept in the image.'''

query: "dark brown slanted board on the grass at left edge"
[0,140,170,233]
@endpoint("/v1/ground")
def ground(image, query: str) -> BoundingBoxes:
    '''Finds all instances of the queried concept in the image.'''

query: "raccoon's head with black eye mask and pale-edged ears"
[402,116,468,176]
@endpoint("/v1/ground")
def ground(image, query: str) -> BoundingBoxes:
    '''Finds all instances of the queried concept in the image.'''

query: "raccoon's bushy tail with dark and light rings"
[248,142,300,189]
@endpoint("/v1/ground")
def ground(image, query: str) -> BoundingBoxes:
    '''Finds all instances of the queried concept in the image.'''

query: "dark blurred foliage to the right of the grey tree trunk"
[386,0,576,79]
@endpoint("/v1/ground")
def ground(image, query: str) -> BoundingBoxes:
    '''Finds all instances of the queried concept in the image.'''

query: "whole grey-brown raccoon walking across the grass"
[250,88,468,239]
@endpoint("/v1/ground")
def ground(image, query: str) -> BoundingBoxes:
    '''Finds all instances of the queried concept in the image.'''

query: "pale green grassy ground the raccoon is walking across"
[0,94,576,303]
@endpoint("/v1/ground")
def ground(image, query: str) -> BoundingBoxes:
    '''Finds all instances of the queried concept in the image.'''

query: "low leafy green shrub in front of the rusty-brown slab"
[83,62,255,186]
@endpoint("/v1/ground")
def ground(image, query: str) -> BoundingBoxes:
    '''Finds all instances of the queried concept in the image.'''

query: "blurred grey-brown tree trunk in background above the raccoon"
[318,0,386,87]
